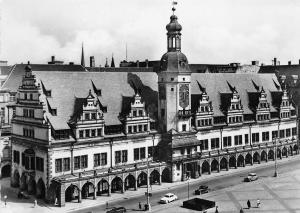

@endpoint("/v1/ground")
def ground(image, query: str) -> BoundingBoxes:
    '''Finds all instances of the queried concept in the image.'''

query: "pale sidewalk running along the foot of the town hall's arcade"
[0,155,300,213]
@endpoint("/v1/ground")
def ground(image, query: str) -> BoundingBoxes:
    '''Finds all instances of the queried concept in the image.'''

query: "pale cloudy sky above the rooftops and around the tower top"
[0,0,300,66]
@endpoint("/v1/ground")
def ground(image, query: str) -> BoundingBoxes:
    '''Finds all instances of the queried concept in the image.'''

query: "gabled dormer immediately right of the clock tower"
[195,82,214,129]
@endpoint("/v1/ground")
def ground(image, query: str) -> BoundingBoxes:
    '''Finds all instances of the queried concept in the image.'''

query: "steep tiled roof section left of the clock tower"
[33,71,157,129]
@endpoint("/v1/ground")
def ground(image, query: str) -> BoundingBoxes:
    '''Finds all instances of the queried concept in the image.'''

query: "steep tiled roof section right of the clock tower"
[191,73,280,116]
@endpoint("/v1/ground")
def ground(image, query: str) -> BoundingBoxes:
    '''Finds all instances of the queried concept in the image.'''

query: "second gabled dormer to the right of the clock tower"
[227,87,244,125]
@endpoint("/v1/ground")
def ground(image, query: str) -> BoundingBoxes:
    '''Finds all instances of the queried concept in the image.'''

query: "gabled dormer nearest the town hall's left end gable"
[70,90,105,140]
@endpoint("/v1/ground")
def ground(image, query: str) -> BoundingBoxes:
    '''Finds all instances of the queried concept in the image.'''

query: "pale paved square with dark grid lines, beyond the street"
[153,163,300,213]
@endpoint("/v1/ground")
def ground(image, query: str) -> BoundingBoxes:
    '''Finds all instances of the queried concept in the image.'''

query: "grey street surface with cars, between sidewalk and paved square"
[73,161,300,213]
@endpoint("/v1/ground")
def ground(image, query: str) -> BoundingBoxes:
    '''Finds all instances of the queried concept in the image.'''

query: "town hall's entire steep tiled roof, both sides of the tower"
[15,71,281,129]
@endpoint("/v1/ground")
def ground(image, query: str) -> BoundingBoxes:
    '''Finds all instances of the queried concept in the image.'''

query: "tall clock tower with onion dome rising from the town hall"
[158,7,191,132]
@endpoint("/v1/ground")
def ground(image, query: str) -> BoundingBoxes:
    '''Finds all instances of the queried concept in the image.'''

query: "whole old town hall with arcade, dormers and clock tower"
[11,8,298,206]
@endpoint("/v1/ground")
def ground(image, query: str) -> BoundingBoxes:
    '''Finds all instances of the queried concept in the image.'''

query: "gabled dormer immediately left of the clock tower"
[121,93,150,135]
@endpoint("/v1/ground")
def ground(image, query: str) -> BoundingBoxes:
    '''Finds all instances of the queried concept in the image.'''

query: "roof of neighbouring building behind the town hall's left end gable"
[1,64,86,92]
